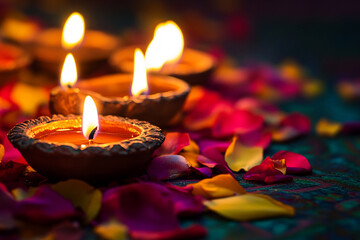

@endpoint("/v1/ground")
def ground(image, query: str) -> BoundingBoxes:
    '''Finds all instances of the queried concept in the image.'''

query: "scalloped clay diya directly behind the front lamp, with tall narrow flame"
[49,50,190,126]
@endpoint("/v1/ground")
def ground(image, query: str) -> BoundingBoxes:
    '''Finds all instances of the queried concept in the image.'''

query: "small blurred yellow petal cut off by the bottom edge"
[94,220,128,240]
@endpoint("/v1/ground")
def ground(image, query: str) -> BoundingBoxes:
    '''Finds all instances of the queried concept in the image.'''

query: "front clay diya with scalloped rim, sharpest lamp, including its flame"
[8,97,164,183]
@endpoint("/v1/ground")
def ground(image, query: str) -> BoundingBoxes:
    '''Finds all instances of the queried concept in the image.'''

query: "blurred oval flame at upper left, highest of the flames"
[61,12,85,50]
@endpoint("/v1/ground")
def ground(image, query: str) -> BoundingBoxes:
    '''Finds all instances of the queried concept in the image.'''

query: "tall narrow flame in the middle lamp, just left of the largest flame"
[131,48,148,96]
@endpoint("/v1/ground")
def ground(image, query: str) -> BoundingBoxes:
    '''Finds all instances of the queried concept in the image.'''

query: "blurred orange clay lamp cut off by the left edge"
[0,42,31,86]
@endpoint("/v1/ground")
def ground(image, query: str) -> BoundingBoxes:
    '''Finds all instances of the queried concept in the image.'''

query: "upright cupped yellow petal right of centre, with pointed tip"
[225,137,264,172]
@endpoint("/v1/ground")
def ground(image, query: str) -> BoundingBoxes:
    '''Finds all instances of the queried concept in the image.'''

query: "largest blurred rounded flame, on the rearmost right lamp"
[145,21,184,71]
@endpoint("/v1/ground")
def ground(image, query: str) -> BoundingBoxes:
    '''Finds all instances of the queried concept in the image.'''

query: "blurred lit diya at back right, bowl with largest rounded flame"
[110,21,216,85]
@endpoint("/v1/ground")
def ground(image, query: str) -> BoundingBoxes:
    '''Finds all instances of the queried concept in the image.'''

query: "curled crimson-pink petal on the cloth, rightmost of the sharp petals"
[272,151,312,174]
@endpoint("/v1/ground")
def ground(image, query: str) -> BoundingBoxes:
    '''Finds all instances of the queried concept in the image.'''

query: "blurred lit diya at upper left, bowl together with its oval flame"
[31,12,119,75]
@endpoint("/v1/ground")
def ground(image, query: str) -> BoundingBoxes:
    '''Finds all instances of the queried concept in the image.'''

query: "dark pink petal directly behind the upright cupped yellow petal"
[238,130,272,149]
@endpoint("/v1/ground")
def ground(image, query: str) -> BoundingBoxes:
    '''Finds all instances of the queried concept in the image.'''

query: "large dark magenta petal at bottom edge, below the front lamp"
[99,183,206,239]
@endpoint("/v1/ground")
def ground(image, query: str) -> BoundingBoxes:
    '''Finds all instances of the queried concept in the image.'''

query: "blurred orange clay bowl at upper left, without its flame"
[30,28,119,76]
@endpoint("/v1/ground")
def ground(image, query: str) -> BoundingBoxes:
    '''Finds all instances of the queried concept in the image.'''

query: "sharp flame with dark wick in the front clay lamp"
[82,96,99,140]
